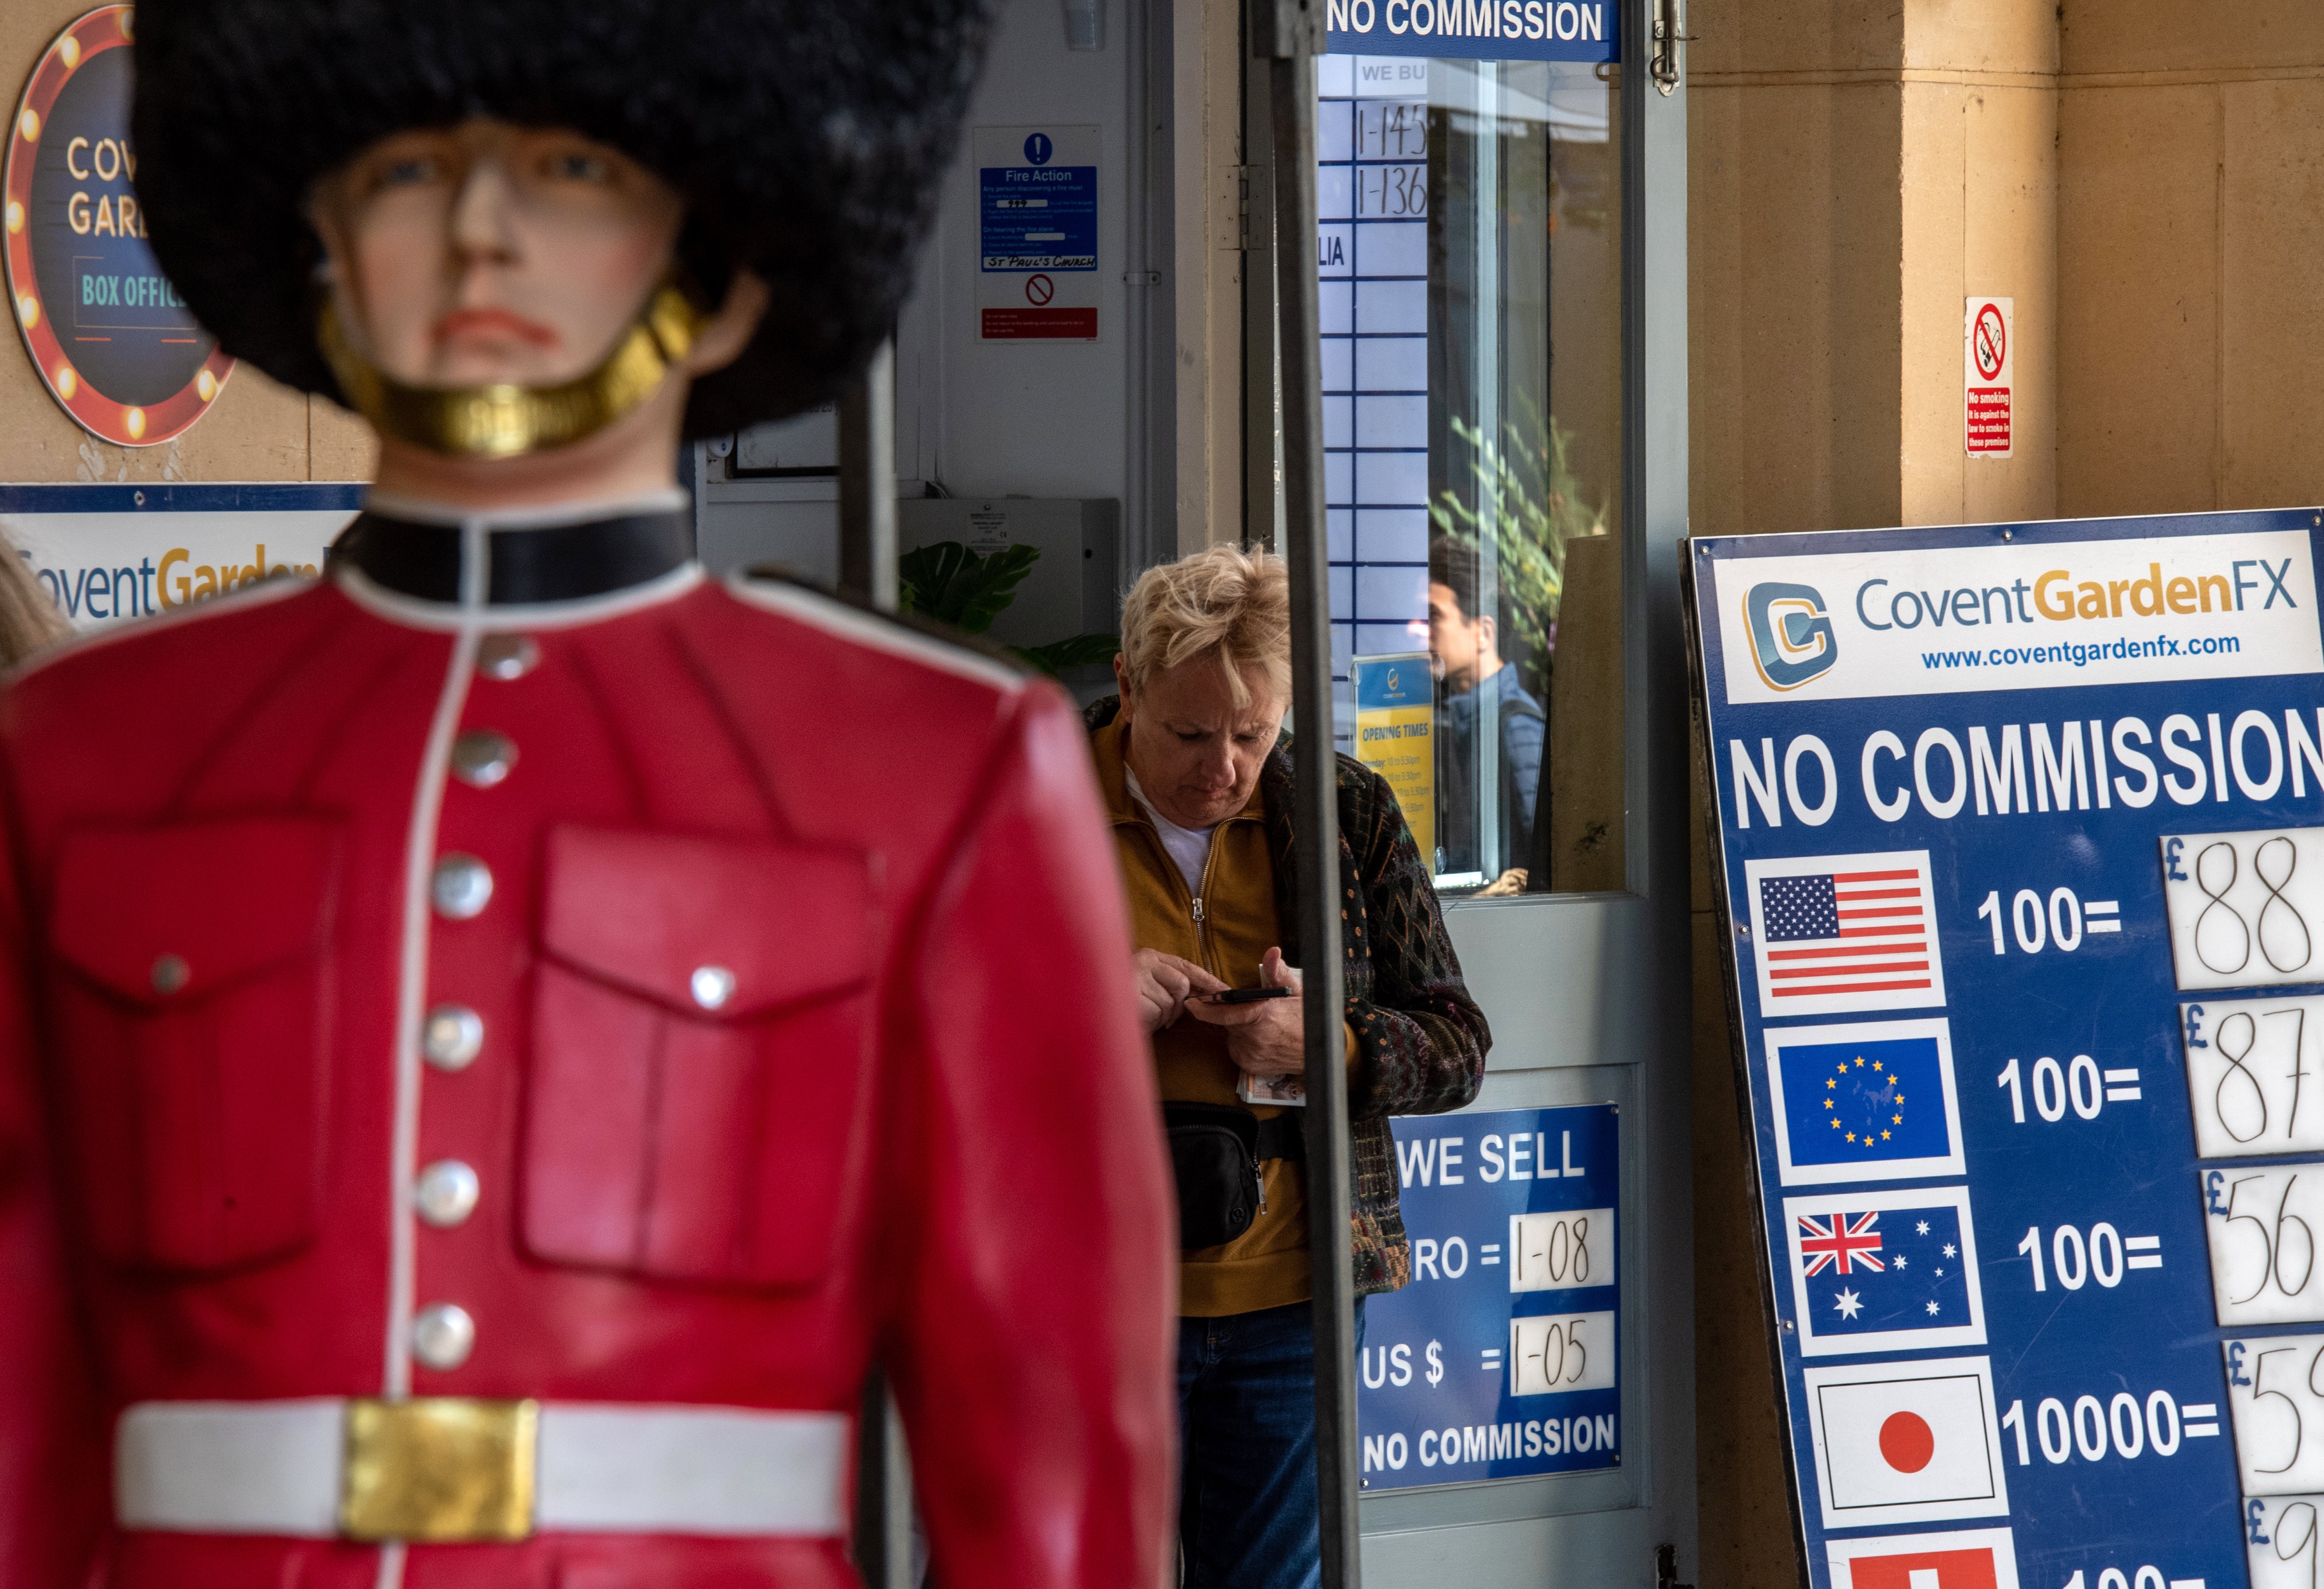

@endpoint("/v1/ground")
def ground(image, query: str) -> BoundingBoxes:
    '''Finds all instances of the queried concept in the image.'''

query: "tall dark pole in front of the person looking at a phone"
[1250,0,1364,1589]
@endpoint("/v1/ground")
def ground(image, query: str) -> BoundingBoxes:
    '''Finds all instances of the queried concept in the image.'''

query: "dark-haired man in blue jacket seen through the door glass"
[1429,536,1548,892]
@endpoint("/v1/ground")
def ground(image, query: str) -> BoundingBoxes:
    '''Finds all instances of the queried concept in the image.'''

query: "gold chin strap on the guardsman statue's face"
[316,283,704,458]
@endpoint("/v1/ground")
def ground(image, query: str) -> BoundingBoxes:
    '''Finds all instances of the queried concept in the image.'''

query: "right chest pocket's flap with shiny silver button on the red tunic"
[541,827,874,1020]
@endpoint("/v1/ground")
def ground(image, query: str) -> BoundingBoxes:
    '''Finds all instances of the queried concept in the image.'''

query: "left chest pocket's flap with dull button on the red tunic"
[49,815,339,1004]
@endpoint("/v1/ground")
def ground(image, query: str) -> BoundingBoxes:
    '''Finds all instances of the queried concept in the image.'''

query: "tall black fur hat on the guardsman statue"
[133,0,988,437]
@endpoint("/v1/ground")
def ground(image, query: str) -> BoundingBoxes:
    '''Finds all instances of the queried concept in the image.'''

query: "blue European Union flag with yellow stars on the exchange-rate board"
[1778,1036,1952,1166]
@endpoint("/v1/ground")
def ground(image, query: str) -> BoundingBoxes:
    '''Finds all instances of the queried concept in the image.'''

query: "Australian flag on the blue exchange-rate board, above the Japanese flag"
[1789,1194,1976,1340]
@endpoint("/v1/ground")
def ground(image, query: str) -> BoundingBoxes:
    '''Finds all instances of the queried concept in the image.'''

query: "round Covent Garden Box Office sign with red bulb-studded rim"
[7,4,235,446]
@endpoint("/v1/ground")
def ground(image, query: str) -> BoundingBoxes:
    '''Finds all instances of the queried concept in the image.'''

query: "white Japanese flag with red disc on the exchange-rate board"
[1806,1357,2010,1524]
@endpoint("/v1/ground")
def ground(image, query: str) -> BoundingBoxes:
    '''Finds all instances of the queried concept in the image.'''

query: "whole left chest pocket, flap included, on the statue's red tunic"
[49,818,342,1273]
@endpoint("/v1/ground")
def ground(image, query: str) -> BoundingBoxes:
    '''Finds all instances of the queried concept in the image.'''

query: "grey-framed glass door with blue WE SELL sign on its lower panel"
[1292,0,1692,1589]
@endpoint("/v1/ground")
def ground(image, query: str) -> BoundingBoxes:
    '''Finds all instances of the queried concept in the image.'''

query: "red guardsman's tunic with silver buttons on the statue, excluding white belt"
[0,555,1174,1589]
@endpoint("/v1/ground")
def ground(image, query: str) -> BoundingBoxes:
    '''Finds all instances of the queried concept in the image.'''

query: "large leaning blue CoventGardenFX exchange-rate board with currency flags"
[1690,511,2324,1589]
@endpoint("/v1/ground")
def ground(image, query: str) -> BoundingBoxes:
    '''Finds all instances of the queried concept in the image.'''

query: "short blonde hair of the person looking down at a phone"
[1123,546,1292,708]
